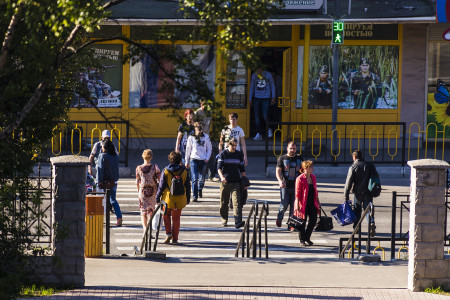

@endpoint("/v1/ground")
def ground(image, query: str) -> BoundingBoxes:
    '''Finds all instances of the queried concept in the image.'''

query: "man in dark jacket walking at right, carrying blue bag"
[344,150,376,237]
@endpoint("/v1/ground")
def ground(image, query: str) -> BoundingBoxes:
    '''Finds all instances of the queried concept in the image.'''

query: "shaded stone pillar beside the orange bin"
[50,155,89,287]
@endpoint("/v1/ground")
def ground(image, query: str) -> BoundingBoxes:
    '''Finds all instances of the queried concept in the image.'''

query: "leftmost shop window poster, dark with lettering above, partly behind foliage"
[71,44,123,108]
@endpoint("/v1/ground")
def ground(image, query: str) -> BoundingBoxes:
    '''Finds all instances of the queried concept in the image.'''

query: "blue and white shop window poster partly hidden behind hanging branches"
[129,45,216,108]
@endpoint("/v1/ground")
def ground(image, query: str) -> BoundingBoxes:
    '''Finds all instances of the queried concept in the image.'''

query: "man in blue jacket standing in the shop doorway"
[249,67,275,141]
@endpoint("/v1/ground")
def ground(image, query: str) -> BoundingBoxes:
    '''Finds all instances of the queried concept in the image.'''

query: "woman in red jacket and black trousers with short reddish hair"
[294,160,320,246]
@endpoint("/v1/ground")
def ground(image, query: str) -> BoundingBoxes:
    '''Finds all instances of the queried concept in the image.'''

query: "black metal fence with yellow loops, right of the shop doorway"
[265,122,450,168]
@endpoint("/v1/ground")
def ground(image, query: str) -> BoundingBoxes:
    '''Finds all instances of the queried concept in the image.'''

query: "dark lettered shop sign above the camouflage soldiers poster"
[311,23,398,40]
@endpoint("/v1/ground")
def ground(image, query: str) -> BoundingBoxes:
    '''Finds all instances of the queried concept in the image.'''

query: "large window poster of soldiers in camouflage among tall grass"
[308,46,399,109]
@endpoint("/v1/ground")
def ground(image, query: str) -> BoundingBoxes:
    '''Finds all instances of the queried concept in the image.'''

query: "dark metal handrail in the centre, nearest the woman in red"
[234,201,269,258]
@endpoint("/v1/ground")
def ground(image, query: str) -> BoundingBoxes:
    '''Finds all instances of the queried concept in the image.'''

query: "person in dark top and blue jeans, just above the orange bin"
[97,140,122,227]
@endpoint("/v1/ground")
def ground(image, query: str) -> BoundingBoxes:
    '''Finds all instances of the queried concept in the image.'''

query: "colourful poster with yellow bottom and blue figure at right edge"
[427,43,450,138]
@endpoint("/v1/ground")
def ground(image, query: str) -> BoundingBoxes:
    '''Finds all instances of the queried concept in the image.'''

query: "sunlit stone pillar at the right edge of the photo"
[408,159,450,291]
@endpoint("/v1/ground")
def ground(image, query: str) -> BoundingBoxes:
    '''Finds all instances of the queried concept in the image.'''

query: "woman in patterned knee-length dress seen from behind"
[136,149,161,232]
